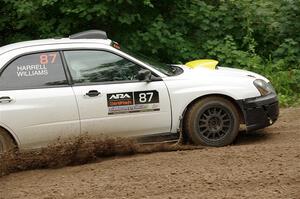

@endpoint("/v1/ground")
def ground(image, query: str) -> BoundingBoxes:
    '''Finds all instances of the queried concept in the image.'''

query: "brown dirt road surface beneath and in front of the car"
[0,108,300,199]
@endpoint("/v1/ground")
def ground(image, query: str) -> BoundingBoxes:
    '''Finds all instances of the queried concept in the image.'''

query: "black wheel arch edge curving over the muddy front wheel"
[180,93,245,141]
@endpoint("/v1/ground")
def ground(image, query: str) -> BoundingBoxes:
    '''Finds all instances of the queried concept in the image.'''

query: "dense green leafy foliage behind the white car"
[0,0,300,106]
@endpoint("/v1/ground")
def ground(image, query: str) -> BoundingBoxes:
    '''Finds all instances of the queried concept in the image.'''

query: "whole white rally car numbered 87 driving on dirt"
[0,31,279,152]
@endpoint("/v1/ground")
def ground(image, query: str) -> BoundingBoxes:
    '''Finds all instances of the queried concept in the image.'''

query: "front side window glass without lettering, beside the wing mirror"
[64,50,141,83]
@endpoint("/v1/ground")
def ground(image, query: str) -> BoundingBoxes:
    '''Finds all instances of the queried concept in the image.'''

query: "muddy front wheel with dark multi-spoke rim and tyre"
[184,97,240,147]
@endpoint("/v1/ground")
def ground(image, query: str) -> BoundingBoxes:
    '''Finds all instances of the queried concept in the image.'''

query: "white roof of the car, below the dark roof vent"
[0,38,112,55]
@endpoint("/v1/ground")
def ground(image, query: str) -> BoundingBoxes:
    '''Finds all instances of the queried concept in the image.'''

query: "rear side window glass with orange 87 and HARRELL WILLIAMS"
[0,52,67,90]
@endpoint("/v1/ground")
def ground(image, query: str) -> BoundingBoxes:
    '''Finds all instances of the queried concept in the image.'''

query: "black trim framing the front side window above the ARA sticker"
[61,48,162,86]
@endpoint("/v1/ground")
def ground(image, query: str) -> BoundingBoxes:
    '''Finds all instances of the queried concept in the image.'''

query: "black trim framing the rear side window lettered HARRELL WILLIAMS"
[0,49,71,91]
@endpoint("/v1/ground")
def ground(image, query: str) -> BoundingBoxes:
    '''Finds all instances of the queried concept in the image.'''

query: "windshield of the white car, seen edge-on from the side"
[118,47,183,76]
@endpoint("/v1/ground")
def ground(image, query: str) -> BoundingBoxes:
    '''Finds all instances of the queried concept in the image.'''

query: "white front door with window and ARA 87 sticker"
[64,50,171,136]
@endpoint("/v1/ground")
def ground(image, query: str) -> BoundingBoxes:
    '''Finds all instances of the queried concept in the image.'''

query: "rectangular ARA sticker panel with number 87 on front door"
[107,90,160,114]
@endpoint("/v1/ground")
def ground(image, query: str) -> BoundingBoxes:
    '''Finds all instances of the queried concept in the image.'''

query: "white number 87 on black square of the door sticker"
[134,90,159,104]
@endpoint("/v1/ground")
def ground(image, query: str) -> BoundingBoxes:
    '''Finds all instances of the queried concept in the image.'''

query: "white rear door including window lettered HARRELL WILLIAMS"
[0,52,80,148]
